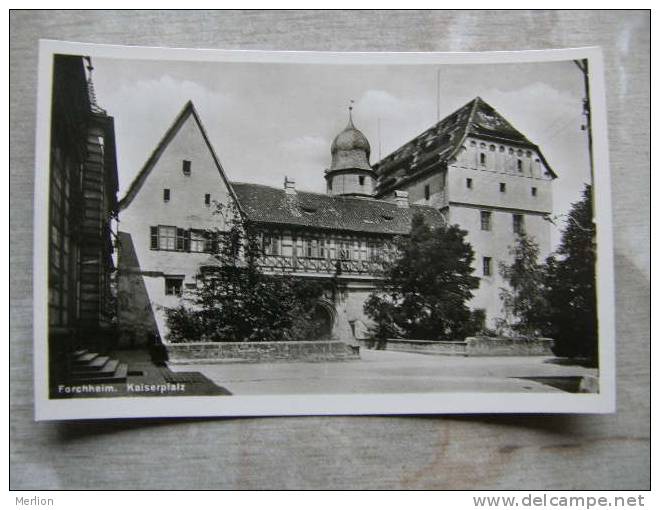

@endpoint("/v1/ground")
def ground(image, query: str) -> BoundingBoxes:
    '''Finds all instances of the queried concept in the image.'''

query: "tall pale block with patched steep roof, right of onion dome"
[374,97,556,327]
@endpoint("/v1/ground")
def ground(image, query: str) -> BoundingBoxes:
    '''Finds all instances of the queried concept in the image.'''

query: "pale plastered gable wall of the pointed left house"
[118,111,232,344]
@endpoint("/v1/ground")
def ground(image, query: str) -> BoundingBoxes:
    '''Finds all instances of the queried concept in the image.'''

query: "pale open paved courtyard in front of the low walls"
[170,349,597,395]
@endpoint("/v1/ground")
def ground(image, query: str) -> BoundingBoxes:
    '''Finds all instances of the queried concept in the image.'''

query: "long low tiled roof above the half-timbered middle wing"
[231,182,444,235]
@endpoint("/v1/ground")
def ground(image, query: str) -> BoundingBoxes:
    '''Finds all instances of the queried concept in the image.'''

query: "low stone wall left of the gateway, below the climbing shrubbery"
[165,340,360,365]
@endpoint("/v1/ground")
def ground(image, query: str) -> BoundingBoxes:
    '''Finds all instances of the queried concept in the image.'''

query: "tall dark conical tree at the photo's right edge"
[546,185,598,363]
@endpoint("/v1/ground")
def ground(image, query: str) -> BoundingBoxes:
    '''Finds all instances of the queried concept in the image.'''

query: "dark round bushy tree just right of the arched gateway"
[364,214,479,340]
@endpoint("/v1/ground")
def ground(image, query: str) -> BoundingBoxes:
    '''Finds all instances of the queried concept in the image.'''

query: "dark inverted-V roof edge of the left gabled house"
[119,101,240,210]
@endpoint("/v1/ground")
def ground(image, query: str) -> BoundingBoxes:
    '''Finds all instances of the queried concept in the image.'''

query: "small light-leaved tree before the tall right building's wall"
[500,233,548,336]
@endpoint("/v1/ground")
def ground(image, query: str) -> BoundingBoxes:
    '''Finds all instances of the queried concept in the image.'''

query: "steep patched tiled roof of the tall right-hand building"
[373,97,556,195]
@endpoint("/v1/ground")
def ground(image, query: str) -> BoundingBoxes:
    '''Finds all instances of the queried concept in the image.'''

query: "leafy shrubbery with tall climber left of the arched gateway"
[165,203,325,342]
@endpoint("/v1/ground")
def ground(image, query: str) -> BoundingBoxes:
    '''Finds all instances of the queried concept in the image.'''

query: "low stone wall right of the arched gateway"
[386,336,554,356]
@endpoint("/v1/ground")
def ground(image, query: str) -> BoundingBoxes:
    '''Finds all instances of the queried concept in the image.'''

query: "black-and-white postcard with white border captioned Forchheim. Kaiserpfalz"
[34,41,615,420]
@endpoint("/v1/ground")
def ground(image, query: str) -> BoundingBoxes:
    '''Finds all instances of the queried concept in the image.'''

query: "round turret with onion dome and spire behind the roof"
[325,101,376,197]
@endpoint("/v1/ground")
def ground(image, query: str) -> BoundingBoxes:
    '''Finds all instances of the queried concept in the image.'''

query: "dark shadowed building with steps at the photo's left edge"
[48,55,122,390]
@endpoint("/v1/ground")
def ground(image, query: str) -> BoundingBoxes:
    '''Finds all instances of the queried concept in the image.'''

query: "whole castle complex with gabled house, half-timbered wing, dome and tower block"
[118,98,555,345]
